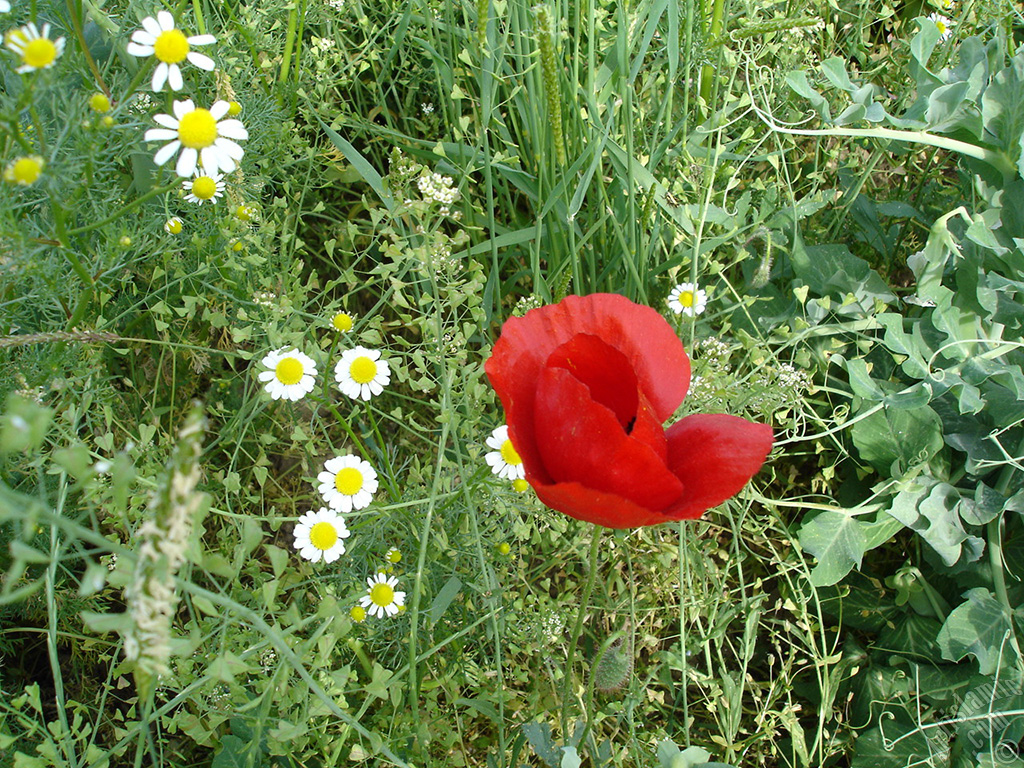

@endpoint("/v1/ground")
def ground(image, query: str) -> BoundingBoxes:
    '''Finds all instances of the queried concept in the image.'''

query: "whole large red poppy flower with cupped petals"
[484,294,772,528]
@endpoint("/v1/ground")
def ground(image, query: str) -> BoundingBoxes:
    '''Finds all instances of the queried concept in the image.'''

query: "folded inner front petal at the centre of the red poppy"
[532,368,683,510]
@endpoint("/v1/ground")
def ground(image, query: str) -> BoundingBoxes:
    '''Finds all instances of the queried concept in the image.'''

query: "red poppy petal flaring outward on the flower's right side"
[665,414,772,520]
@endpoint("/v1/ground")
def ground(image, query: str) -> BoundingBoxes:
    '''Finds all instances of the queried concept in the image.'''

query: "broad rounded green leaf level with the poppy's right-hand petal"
[850,406,943,477]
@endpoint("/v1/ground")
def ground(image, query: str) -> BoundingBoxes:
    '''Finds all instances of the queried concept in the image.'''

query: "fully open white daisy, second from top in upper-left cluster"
[145,98,249,178]
